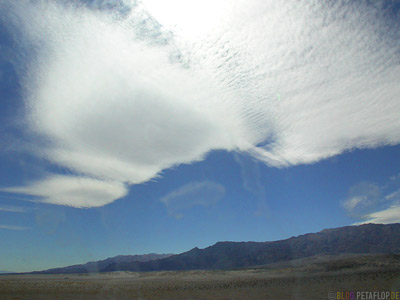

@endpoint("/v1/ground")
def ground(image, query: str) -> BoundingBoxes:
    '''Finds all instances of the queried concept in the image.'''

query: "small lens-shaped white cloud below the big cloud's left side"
[2,175,127,207]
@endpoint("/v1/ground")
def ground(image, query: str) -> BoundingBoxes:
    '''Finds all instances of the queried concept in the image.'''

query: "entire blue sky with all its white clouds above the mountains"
[0,0,400,272]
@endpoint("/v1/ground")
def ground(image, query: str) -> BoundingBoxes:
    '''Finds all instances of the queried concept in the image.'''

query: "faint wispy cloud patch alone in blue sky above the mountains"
[161,181,225,219]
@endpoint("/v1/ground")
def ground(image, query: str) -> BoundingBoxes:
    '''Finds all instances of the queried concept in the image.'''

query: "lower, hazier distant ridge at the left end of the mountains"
[32,253,173,274]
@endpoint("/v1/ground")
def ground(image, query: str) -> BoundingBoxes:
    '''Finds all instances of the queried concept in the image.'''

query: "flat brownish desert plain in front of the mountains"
[0,255,400,300]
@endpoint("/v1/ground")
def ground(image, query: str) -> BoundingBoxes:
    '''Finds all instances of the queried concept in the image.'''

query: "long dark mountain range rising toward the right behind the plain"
[35,224,400,273]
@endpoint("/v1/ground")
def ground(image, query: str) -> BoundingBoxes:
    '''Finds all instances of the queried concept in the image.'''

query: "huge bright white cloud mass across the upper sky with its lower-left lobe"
[0,0,400,207]
